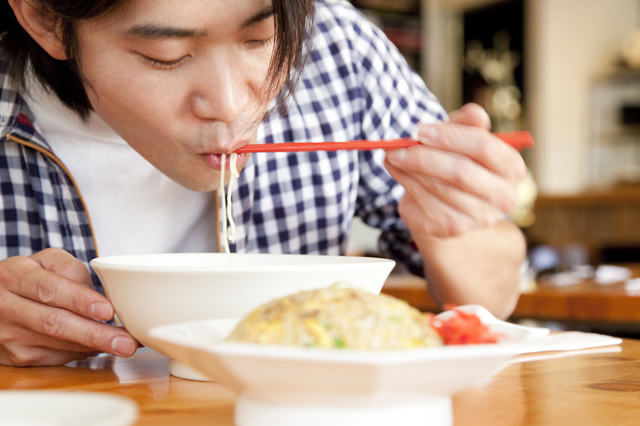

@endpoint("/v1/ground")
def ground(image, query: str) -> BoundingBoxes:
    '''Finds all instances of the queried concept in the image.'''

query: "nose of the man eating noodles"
[190,55,251,123]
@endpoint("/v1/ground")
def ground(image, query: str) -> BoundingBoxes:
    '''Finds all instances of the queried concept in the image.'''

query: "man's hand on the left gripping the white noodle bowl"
[0,248,138,366]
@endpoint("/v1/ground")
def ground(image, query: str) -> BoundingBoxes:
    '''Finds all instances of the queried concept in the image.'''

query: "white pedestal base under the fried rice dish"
[235,395,453,426]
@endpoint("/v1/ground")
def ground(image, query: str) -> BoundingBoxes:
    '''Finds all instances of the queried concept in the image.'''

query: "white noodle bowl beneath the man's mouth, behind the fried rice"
[91,253,395,380]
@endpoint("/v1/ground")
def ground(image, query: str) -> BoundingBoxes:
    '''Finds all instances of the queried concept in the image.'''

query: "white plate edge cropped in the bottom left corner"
[0,391,138,426]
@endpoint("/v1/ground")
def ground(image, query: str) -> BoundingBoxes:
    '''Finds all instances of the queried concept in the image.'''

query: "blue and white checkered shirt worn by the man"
[0,0,445,290]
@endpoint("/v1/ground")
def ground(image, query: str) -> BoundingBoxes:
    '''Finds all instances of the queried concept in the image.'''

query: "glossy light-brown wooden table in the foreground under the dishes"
[0,340,640,426]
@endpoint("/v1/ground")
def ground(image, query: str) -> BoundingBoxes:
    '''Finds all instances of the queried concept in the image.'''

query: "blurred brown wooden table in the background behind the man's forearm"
[382,265,640,326]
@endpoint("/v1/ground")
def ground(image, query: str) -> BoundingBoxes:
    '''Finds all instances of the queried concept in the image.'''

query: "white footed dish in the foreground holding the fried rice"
[149,306,549,426]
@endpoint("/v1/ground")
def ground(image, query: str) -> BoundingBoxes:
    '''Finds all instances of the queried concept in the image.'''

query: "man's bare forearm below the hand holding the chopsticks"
[414,221,526,318]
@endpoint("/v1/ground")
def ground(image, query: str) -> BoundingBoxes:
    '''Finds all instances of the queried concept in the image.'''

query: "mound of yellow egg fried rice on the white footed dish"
[227,287,443,351]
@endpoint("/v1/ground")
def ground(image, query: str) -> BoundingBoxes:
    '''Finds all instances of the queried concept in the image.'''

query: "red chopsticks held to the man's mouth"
[235,130,534,154]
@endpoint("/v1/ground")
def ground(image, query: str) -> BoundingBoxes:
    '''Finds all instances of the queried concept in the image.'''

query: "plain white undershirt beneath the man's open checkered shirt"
[27,81,218,256]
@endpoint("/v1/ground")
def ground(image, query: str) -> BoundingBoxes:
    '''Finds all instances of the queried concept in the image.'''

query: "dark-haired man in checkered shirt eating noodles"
[0,0,525,365]
